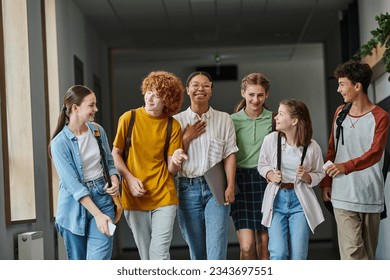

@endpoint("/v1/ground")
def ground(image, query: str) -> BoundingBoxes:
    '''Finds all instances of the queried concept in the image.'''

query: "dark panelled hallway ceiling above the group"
[73,0,353,61]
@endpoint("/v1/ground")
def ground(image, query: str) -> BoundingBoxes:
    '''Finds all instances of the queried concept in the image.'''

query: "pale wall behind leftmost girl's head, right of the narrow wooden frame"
[56,0,112,138]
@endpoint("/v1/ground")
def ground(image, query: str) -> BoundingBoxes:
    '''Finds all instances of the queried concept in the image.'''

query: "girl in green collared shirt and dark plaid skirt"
[231,73,273,260]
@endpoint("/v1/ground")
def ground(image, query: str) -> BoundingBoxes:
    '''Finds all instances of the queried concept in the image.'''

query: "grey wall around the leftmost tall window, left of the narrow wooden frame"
[0,0,54,259]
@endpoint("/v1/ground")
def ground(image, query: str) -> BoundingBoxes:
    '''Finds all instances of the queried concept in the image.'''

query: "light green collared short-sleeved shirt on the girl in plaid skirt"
[231,108,272,168]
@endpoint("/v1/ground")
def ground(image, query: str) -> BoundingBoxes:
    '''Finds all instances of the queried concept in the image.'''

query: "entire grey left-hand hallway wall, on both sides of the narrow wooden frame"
[0,0,111,260]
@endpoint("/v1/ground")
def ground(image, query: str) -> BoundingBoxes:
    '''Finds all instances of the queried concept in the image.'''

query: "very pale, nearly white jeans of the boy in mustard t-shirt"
[123,205,177,260]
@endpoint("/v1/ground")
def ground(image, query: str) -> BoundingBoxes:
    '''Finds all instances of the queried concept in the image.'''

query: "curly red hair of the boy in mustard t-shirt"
[141,71,184,116]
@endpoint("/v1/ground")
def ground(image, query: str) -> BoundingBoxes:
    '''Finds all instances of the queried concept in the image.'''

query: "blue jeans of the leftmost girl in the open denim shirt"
[56,179,115,260]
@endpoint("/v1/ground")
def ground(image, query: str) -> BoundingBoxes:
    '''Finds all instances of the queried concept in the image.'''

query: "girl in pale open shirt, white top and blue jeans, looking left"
[258,100,325,260]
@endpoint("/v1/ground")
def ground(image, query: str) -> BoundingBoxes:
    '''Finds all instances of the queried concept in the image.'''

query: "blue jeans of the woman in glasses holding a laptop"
[178,177,230,260]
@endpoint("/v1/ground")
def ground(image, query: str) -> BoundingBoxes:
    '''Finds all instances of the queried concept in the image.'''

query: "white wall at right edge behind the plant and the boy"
[359,0,390,260]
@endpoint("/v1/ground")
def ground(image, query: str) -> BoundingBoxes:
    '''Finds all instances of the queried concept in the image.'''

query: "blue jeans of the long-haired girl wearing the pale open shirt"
[268,189,310,260]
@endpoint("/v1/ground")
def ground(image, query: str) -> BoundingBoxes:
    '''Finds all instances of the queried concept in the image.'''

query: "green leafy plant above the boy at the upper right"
[354,12,390,81]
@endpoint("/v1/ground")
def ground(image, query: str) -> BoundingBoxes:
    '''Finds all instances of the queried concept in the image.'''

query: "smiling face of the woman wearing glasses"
[187,75,212,103]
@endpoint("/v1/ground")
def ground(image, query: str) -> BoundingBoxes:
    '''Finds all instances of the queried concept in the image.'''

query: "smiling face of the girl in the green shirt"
[241,85,268,113]
